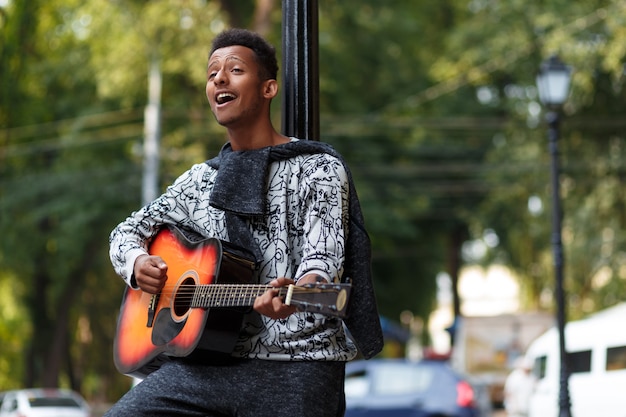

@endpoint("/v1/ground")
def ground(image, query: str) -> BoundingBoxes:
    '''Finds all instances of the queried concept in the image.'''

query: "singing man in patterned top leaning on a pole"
[106,29,382,417]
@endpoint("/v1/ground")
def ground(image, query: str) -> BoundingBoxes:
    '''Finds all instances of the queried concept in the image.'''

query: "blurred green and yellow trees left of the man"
[0,0,278,398]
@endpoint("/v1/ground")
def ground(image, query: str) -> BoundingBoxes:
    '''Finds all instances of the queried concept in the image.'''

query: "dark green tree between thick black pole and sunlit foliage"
[320,0,498,319]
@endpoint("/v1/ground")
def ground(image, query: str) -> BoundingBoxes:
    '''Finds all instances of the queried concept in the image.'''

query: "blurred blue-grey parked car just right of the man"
[345,359,490,417]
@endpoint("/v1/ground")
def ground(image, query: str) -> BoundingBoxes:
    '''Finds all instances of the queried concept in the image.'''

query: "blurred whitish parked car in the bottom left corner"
[0,388,91,417]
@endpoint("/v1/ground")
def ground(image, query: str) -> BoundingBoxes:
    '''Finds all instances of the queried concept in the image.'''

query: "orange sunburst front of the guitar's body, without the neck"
[113,229,222,377]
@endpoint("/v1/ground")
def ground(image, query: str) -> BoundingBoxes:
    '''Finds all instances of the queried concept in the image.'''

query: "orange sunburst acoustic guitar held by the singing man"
[113,227,351,378]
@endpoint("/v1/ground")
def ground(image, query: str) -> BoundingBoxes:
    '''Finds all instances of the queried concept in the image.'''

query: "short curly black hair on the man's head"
[209,28,278,80]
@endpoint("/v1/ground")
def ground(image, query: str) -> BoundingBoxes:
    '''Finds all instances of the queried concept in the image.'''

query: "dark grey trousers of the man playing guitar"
[105,359,345,417]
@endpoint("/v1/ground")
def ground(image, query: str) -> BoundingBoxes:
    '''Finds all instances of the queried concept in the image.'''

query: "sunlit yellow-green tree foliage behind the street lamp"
[426,1,624,315]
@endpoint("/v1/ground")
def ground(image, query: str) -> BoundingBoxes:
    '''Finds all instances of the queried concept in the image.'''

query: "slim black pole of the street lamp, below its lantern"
[546,111,571,417]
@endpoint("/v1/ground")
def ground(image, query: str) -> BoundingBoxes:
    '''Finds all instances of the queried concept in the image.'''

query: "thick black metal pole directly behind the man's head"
[282,0,320,140]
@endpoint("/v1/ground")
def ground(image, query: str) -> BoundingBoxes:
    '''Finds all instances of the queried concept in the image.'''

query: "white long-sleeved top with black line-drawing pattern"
[110,139,356,361]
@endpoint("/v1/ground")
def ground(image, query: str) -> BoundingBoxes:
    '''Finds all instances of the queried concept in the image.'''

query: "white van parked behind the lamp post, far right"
[526,303,626,417]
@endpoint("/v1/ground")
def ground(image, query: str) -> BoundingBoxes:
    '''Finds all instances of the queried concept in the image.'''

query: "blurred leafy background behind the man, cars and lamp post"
[0,0,626,412]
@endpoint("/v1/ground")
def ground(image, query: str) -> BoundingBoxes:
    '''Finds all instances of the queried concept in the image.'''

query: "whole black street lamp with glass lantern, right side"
[537,56,572,417]
